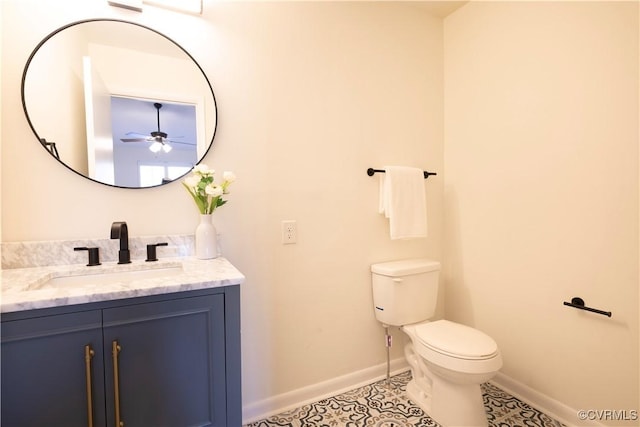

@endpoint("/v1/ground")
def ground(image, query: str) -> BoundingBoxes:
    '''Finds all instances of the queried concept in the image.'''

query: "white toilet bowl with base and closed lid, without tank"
[401,320,502,427]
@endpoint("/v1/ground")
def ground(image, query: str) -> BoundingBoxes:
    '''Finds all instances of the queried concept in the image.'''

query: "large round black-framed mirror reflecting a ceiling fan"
[22,20,216,188]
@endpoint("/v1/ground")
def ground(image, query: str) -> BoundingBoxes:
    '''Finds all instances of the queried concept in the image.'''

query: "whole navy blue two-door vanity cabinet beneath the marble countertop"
[1,286,242,427]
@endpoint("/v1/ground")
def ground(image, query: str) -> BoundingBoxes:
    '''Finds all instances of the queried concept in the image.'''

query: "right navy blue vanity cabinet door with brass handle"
[103,293,227,427]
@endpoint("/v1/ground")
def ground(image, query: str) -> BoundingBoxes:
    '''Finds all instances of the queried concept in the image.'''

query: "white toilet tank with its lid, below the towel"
[371,258,440,326]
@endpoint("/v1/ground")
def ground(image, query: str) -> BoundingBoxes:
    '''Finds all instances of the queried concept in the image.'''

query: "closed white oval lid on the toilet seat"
[416,320,498,359]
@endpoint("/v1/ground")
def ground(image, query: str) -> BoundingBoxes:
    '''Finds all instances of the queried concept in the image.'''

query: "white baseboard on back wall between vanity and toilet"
[242,357,409,424]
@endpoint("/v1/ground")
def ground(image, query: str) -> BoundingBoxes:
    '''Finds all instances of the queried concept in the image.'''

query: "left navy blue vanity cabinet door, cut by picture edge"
[0,310,105,427]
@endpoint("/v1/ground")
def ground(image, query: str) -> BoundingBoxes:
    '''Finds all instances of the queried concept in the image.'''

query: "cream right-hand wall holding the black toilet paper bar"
[444,2,639,425]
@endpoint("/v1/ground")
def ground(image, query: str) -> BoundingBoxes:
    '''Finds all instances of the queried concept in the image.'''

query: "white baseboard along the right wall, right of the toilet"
[491,372,603,427]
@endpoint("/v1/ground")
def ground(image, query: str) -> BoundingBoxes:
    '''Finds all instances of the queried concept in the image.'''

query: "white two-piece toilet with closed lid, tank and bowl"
[371,259,502,427]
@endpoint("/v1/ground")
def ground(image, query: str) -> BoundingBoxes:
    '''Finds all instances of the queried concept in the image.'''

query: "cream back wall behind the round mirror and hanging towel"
[2,0,443,422]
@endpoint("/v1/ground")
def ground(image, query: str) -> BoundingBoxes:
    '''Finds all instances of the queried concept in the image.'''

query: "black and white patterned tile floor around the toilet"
[245,371,563,427]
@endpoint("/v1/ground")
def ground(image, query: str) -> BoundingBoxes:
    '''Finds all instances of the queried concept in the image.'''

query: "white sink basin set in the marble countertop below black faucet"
[29,265,183,290]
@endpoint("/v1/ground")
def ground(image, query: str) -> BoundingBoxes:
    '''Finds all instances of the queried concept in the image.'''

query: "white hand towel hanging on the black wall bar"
[379,166,427,240]
